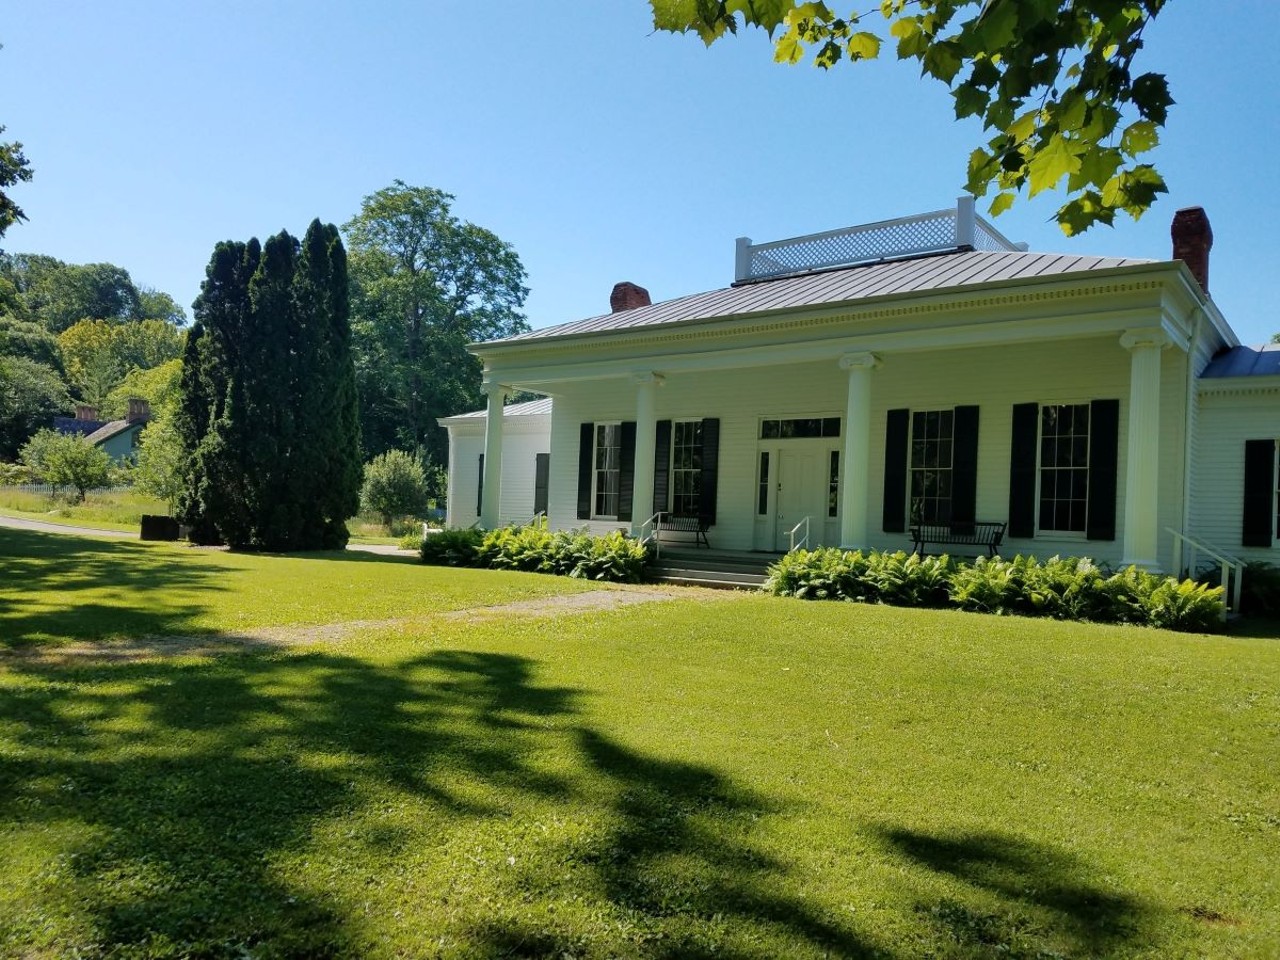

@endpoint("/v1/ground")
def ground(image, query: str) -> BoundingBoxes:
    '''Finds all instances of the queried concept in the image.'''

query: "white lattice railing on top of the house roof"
[733,197,1027,283]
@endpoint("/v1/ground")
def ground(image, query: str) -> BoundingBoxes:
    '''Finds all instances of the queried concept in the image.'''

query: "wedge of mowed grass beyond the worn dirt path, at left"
[0,529,593,650]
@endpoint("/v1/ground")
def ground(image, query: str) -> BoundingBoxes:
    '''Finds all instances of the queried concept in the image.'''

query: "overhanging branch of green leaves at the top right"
[650,0,1174,234]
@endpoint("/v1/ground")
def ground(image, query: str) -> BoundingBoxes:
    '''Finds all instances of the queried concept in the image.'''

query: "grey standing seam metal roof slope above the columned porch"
[477,251,1160,346]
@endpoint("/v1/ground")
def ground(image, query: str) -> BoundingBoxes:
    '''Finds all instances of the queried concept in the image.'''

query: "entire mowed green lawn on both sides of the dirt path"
[0,532,1280,957]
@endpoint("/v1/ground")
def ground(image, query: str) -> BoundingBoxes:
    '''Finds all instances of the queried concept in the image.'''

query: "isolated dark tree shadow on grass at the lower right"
[877,827,1157,957]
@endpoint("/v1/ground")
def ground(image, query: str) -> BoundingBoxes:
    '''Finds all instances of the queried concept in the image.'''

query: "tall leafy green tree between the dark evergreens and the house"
[344,180,529,463]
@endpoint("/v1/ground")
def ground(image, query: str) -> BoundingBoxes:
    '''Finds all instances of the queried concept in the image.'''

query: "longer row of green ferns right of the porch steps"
[764,548,1224,631]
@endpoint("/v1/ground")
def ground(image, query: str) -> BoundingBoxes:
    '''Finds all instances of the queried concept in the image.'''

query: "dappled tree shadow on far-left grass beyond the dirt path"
[0,529,224,650]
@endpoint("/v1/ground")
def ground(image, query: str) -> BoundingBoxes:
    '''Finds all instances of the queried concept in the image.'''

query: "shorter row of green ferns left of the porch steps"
[421,526,649,584]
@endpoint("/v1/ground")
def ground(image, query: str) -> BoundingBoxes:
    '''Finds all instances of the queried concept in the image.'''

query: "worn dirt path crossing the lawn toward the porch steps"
[0,586,744,663]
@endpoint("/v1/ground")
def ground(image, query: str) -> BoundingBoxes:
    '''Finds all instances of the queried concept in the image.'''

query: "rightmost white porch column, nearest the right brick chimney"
[1120,328,1170,570]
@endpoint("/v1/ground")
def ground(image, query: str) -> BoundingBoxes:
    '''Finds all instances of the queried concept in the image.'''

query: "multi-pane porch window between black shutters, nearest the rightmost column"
[1039,403,1089,534]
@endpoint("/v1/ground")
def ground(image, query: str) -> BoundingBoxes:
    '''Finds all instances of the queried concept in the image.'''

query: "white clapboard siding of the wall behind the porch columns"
[547,337,1187,563]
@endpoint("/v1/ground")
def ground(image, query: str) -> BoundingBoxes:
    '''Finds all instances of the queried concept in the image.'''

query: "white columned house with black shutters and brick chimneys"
[440,198,1280,568]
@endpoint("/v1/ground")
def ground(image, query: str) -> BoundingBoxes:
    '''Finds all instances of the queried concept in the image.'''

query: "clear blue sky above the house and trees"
[0,0,1280,342]
